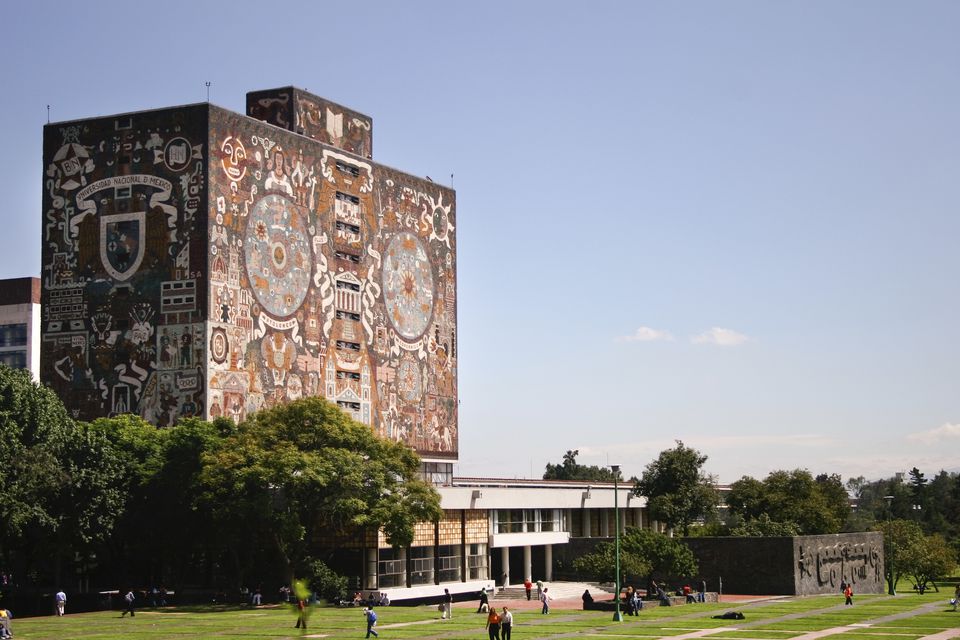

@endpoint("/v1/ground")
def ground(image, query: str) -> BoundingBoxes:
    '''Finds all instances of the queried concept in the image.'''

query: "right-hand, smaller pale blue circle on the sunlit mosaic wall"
[383,231,433,340]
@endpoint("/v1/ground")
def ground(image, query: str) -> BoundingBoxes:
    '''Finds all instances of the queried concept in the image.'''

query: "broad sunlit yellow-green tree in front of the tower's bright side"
[201,398,442,578]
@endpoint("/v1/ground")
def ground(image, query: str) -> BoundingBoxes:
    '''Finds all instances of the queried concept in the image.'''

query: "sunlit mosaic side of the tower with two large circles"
[207,104,457,458]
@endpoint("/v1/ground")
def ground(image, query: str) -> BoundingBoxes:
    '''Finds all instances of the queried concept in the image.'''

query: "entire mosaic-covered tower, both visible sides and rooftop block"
[42,89,457,458]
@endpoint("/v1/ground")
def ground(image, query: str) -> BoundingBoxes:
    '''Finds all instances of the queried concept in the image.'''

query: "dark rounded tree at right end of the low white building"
[633,440,720,535]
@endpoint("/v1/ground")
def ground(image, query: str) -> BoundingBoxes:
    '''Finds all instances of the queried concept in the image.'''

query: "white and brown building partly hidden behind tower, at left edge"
[0,278,40,381]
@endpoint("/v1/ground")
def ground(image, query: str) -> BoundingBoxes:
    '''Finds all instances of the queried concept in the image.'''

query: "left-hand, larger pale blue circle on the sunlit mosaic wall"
[243,195,313,317]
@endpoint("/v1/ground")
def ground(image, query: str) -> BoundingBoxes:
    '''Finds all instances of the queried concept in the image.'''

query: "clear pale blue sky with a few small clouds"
[0,1,960,482]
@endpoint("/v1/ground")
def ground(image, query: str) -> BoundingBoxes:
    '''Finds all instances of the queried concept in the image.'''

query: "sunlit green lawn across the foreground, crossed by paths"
[13,593,960,640]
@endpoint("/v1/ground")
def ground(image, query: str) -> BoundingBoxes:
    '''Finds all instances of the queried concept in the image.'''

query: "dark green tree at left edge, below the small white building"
[0,365,124,583]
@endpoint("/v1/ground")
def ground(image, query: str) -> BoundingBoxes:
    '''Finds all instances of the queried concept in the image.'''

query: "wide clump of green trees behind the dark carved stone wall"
[726,469,850,535]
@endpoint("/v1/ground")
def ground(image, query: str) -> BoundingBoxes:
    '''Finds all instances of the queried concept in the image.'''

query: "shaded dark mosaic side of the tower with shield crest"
[40,105,207,426]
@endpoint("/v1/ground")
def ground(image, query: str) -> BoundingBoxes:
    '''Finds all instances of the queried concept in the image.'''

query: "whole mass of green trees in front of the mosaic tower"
[0,366,442,590]
